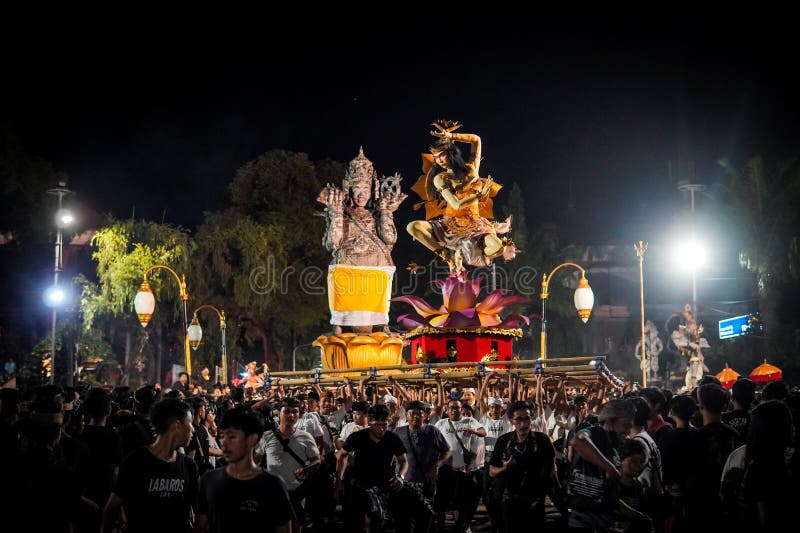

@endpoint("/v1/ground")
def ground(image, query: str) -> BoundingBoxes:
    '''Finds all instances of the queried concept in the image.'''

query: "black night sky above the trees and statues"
[2,9,800,242]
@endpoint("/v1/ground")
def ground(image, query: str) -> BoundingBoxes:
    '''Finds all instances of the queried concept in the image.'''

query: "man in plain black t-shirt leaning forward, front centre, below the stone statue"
[336,404,408,531]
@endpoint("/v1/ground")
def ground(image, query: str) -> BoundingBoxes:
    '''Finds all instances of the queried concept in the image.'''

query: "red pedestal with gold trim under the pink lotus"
[405,327,522,364]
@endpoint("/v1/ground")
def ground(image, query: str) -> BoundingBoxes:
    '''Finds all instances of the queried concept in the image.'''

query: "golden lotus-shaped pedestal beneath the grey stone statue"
[313,332,405,376]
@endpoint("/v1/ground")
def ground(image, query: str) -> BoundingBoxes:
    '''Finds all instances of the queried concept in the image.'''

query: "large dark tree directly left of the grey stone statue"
[193,150,344,369]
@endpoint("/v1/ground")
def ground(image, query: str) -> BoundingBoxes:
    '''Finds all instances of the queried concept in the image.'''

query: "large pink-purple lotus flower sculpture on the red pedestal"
[392,275,530,329]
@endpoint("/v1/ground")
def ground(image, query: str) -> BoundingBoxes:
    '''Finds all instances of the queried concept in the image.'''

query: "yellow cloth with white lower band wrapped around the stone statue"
[328,265,395,326]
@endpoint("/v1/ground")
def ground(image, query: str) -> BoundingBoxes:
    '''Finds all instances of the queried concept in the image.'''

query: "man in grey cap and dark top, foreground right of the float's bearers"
[567,400,636,529]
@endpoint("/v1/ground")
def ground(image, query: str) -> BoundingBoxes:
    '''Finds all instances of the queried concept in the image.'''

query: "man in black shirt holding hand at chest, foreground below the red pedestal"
[489,401,556,532]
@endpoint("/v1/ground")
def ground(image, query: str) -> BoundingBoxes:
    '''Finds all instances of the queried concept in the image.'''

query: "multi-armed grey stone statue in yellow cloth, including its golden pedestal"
[314,145,406,368]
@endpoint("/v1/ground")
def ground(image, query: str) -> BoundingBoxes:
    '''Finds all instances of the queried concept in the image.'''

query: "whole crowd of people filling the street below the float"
[0,373,800,533]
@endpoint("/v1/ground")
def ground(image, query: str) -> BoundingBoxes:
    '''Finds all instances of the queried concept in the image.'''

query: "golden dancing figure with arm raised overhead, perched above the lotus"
[406,120,517,274]
